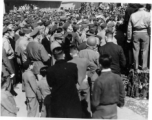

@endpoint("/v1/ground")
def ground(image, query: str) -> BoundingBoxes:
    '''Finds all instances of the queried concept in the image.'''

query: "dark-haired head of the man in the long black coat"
[53,47,65,60]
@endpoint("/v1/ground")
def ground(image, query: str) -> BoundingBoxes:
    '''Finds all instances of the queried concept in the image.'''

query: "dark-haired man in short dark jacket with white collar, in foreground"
[92,54,125,119]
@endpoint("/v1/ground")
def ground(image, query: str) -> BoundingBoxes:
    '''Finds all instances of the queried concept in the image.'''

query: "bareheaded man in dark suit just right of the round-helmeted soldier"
[99,30,126,74]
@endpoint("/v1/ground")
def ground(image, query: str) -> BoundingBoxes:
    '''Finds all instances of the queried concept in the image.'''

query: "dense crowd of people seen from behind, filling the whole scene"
[1,3,151,119]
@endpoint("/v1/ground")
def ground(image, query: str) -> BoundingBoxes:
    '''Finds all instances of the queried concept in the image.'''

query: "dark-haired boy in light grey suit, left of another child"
[22,61,41,117]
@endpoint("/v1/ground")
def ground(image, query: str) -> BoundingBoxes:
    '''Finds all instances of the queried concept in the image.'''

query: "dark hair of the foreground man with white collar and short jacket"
[99,54,112,69]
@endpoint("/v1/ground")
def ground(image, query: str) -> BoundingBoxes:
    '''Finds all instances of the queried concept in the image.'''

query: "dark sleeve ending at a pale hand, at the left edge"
[2,49,14,74]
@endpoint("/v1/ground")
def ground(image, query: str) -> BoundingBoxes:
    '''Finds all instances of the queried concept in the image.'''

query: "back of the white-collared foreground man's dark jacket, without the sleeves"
[94,72,122,105]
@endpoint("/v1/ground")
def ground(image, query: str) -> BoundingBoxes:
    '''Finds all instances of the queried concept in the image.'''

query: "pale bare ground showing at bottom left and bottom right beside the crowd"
[15,84,148,120]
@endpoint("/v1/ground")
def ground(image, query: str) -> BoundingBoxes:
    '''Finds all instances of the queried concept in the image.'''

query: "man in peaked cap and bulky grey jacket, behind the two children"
[26,28,51,79]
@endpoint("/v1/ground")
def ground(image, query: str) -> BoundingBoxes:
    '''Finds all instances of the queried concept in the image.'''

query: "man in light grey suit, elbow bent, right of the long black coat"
[69,45,97,117]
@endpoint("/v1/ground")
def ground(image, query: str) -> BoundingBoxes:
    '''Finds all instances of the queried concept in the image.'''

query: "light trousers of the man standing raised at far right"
[133,32,150,70]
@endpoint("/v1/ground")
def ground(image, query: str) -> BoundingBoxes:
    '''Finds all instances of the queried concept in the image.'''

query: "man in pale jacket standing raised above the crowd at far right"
[127,4,151,71]
